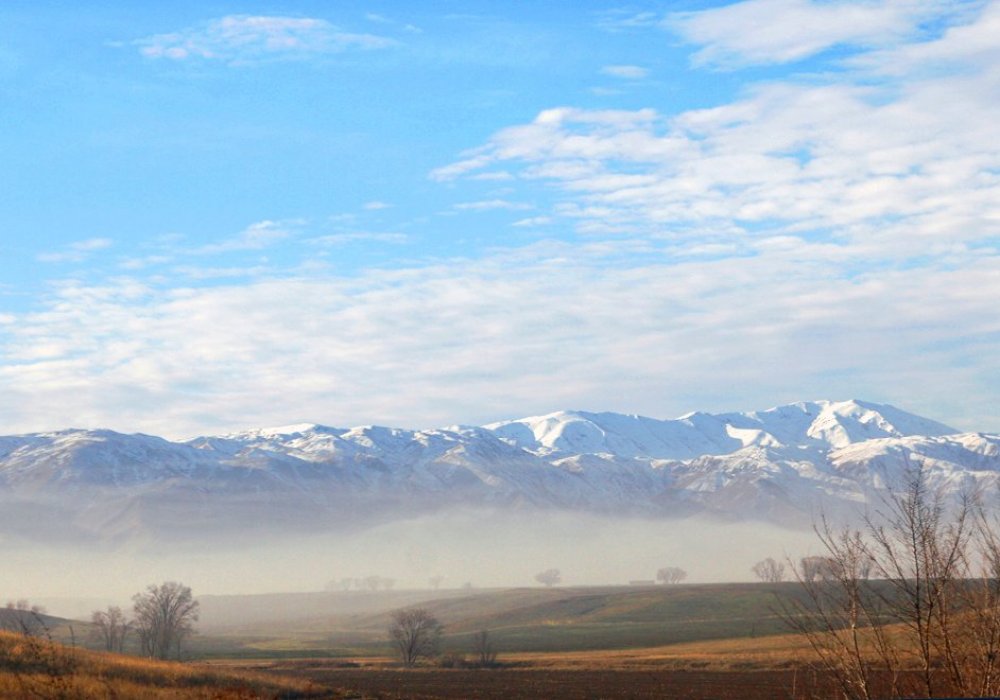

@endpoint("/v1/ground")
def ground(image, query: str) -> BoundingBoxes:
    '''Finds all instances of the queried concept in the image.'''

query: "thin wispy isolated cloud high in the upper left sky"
[134,15,395,64]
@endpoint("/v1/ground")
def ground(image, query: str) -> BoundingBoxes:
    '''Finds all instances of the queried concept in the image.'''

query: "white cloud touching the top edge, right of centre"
[664,0,968,67]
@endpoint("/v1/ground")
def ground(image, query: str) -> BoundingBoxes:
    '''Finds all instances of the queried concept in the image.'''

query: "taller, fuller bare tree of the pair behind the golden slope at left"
[132,581,198,659]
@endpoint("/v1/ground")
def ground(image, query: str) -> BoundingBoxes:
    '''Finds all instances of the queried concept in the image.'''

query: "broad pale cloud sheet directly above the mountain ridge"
[0,230,1000,435]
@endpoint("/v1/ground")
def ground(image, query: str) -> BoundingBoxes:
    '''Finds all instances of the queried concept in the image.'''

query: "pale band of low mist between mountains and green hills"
[0,510,817,615]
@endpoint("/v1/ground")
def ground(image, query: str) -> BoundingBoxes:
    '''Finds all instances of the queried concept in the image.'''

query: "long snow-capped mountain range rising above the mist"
[0,401,1000,541]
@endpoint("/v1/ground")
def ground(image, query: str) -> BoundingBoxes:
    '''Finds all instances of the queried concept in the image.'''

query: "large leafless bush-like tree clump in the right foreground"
[785,465,1000,700]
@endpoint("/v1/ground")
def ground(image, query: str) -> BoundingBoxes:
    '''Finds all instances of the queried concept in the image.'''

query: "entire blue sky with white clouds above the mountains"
[0,0,1000,437]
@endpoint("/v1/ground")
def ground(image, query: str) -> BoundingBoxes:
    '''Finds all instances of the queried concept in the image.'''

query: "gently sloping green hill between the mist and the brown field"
[193,584,799,656]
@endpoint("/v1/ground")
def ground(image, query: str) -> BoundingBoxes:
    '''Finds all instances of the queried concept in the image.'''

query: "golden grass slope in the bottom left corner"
[0,632,337,700]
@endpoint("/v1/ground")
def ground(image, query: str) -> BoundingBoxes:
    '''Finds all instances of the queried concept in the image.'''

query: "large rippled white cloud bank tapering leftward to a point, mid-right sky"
[437,25,1000,254]
